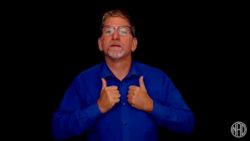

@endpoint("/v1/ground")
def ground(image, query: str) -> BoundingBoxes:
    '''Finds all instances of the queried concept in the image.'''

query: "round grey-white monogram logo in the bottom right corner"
[231,121,247,138]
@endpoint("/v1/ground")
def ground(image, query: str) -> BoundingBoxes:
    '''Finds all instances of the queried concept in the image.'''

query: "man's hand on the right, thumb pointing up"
[127,76,153,112]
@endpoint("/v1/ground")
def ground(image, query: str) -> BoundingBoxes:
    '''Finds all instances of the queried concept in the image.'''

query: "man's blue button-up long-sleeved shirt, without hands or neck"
[52,61,194,141]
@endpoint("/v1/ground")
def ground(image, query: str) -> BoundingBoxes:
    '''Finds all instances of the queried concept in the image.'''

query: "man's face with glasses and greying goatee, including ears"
[98,17,137,60]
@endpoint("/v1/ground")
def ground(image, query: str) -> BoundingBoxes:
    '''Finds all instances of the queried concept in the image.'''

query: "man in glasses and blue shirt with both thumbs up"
[52,10,194,141]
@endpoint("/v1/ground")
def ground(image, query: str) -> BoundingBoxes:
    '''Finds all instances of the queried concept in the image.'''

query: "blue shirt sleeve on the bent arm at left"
[52,76,101,140]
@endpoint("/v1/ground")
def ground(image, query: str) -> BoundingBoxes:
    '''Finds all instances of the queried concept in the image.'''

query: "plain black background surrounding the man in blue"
[5,1,250,140]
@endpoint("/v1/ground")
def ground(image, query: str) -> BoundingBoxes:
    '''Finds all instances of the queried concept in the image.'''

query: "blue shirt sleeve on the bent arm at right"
[151,77,194,133]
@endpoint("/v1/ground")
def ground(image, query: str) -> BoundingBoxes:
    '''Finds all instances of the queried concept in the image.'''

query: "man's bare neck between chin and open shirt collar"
[105,56,132,81]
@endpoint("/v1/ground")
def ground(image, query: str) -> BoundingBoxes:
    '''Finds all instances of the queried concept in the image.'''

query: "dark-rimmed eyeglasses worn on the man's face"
[102,26,131,36]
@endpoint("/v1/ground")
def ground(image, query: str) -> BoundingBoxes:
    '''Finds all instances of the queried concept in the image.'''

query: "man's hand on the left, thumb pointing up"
[97,78,121,113]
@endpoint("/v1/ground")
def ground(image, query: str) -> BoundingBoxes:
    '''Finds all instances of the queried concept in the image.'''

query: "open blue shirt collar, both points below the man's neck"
[100,61,140,78]
